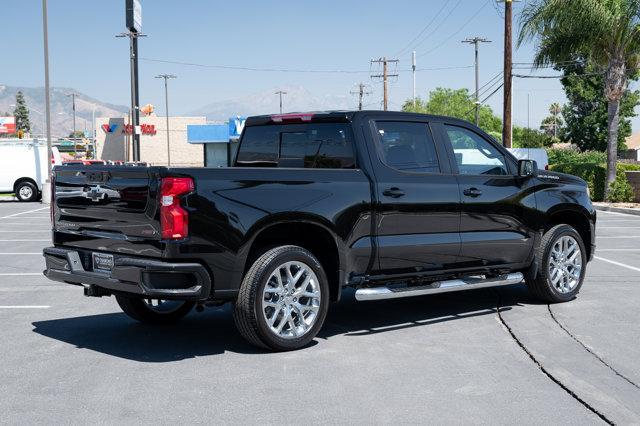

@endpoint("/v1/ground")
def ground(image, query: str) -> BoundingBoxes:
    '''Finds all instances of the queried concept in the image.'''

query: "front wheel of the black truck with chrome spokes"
[526,224,587,303]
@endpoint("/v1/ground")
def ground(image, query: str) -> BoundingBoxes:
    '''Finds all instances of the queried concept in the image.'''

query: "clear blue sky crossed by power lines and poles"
[0,0,624,128]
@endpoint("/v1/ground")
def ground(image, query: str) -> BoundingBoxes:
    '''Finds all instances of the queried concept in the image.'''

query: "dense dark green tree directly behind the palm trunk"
[558,58,640,152]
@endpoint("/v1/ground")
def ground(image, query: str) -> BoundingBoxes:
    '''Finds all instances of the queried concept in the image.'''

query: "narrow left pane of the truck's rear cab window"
[236,126,280,166]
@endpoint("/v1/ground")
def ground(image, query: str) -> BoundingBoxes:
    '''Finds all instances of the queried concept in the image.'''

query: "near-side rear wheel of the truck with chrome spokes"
[233,246,329,351]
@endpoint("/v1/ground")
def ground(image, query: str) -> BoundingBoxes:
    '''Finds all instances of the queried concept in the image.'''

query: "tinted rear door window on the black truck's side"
[376,121,440,173]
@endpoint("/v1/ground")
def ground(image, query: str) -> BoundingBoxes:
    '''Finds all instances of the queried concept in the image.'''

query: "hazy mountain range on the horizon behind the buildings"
[0,84,368,137]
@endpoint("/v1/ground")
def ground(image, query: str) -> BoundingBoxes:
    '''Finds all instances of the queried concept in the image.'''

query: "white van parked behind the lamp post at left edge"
[0,139,62,201]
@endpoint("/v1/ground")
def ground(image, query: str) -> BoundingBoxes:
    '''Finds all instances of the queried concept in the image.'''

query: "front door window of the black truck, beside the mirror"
[445,126,510,175]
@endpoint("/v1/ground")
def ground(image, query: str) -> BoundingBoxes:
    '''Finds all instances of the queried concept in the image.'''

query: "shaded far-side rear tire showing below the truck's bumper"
[116,295,195,324]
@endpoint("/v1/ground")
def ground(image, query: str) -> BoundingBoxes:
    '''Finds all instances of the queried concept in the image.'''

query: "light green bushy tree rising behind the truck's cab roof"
[402,87,502,134]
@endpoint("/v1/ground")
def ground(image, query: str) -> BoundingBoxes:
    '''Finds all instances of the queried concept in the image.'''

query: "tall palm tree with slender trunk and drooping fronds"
[518,0,640,198]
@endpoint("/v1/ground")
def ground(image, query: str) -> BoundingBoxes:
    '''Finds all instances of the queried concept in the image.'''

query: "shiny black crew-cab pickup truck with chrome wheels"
[44,111,596,350]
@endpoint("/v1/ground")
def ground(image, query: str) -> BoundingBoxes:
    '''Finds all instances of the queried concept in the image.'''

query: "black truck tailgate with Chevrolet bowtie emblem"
[53,165,161,257]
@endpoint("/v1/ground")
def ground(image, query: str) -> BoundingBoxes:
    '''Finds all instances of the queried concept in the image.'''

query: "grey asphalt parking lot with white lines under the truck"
[0,202,640,424]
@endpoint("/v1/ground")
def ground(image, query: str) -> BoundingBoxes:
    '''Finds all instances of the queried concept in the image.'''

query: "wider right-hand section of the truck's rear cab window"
[278,123,355,169]
